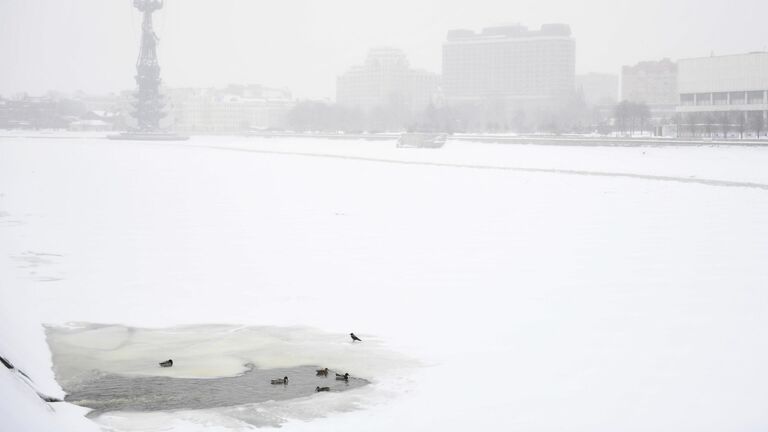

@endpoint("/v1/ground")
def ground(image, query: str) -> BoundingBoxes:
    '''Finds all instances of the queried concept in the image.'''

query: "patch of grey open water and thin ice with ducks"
[46,324,417,429]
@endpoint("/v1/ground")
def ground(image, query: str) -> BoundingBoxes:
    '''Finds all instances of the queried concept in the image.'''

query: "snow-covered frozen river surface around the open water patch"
[0,136,768,432]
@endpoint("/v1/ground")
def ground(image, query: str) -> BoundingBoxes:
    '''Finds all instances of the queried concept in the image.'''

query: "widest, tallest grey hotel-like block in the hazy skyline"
[442,24,575,111]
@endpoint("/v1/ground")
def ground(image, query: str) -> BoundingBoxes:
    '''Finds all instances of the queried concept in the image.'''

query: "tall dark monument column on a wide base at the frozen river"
[108,0,188,140]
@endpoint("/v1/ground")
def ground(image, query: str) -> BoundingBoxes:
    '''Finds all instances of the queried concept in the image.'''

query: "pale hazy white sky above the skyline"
[0,0,768,97]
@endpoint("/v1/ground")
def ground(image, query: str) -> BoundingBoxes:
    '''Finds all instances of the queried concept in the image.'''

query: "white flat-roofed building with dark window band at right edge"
[677,52,768,120]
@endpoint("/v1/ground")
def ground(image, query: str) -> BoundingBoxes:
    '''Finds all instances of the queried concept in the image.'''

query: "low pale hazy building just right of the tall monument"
[166,85,294,133]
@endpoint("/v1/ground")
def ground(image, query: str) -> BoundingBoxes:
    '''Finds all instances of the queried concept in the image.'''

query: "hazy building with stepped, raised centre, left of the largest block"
[336,48,438,112]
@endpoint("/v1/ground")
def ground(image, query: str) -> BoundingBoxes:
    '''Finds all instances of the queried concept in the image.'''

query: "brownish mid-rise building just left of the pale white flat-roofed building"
[621,58,677,119]
